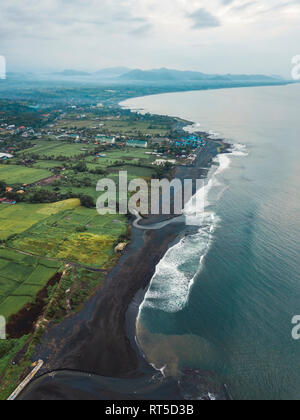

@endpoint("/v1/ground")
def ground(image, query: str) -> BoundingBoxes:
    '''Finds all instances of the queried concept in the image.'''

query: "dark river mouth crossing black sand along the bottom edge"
[18,370,229,401]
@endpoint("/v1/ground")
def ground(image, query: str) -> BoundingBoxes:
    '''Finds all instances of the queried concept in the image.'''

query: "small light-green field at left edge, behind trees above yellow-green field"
[0,165,51,185]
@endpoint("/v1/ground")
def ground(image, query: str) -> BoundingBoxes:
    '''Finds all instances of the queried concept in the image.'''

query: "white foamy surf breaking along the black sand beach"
[140,128,247,313]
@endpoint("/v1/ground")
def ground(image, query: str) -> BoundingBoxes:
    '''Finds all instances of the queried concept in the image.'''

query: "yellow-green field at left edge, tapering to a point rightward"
[0,199,80,240]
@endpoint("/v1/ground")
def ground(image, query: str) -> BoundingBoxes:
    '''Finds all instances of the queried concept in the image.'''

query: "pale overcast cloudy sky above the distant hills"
[0,0,300,76]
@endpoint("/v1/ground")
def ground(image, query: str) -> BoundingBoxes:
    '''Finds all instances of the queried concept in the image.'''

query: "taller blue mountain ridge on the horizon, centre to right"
[119,68,282,82]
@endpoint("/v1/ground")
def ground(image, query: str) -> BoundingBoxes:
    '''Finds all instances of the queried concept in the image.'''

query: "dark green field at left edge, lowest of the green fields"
[0,248,61,320]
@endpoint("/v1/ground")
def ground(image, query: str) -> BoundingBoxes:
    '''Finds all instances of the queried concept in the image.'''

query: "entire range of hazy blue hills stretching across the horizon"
[7,67,291,88]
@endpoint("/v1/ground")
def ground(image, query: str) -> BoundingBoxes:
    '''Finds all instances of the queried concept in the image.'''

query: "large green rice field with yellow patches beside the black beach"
[9,207,126,267]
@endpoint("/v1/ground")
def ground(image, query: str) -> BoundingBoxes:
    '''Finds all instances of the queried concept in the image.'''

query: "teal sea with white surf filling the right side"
[120,85,300,400]
